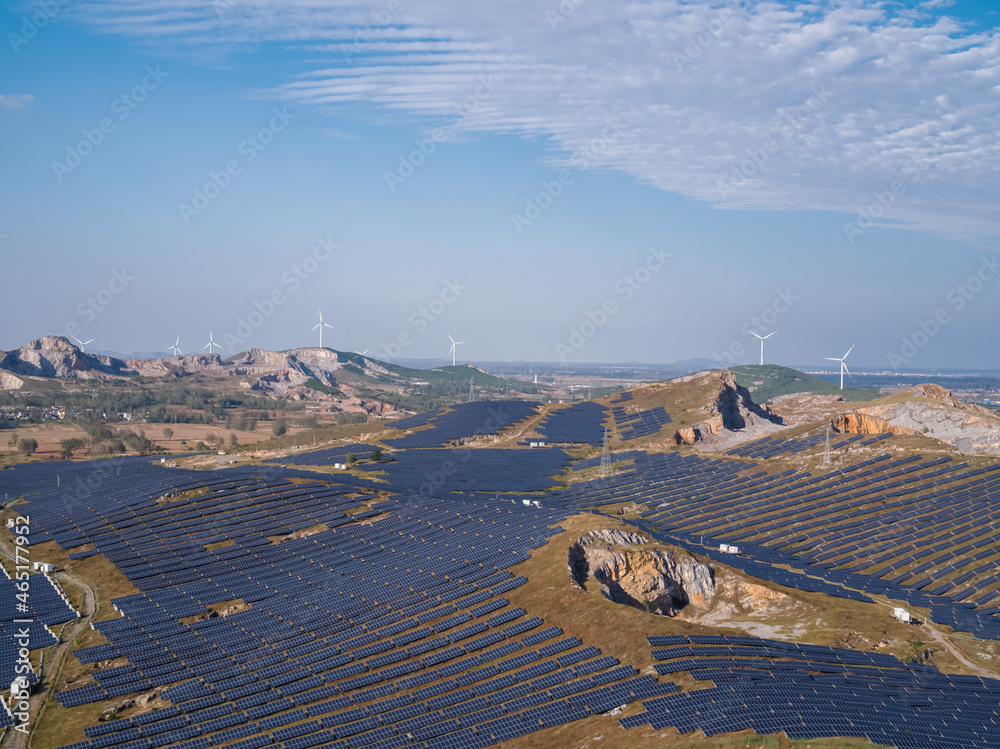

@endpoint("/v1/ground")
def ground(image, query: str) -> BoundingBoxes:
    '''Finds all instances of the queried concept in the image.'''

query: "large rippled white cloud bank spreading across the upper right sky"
[74,0,1000,237]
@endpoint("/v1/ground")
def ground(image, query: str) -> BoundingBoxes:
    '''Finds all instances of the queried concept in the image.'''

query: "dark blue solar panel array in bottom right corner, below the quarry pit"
[620,635,1000,749]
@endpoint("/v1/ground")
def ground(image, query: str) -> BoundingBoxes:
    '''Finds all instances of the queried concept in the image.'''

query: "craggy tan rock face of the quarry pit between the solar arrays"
[569,529,715,616]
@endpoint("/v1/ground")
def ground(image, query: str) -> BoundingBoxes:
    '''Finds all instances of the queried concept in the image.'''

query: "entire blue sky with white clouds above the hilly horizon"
[0,0,1000,369]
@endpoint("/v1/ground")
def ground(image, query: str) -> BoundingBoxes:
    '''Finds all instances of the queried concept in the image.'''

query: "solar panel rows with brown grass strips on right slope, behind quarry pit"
[557,453,1000,639]
